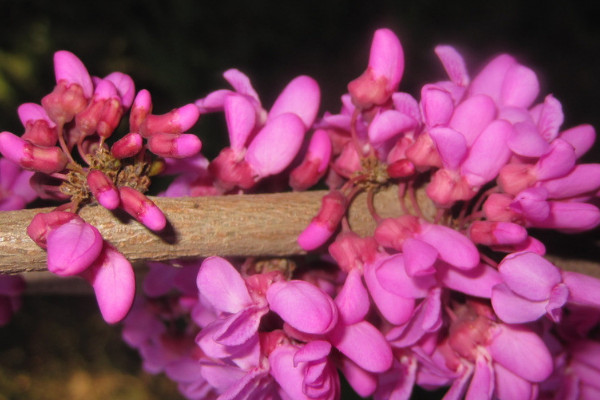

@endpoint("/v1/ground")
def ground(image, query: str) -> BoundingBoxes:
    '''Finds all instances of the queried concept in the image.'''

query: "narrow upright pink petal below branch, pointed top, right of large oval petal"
[335,268,371,325]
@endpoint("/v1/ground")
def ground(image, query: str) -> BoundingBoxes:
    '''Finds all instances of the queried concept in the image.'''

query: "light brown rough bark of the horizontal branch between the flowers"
[0,187,433,273]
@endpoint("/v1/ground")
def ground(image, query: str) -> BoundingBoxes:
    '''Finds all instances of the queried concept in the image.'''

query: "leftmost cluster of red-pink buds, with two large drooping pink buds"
[0,51,201,323]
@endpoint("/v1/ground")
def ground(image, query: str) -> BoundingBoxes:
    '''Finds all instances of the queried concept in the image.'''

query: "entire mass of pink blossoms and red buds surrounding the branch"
[0,29,600,400]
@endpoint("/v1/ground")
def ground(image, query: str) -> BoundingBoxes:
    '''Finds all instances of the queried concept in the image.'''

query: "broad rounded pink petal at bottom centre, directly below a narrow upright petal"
[329,321,393,372]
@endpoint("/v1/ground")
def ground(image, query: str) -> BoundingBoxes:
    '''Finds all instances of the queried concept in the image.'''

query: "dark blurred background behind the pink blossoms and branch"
[0,0,600,400]
